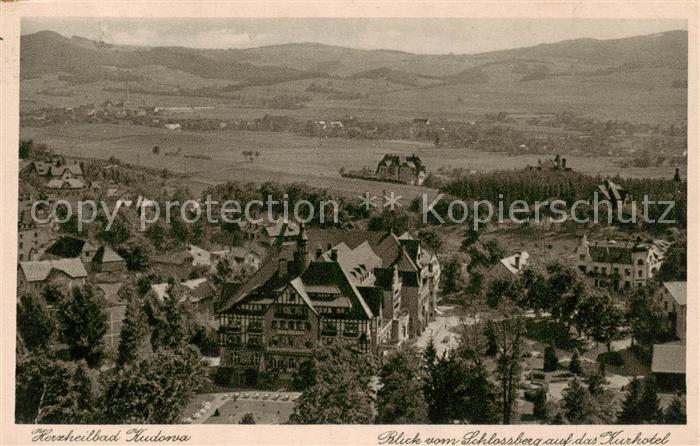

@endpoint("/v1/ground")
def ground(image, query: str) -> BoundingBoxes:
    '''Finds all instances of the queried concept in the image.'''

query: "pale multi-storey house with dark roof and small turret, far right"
[574,235,670,289]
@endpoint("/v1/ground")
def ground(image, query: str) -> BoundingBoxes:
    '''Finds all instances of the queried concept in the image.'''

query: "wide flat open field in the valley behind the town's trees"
[20,124,674,199]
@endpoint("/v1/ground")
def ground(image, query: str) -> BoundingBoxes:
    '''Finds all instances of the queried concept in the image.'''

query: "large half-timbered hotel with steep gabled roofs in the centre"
[218,226,440,374]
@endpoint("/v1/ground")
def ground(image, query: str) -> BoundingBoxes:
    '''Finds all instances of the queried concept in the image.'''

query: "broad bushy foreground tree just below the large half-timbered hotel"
[289,342,375,424]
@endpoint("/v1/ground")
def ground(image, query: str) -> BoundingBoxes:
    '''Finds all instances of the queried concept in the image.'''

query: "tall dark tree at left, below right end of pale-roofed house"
[57,285,107,367]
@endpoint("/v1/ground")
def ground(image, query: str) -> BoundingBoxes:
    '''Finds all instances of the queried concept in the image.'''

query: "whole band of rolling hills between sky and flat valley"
[20,31,688,123]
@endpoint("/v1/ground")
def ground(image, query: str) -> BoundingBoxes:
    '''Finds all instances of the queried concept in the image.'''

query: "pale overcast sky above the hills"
[22,17,687,54]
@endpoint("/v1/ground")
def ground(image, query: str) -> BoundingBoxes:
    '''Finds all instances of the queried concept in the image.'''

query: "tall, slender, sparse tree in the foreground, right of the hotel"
[494,309,525,424]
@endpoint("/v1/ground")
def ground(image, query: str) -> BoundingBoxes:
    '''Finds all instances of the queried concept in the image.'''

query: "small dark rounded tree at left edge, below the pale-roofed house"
[17,293,55,351]
